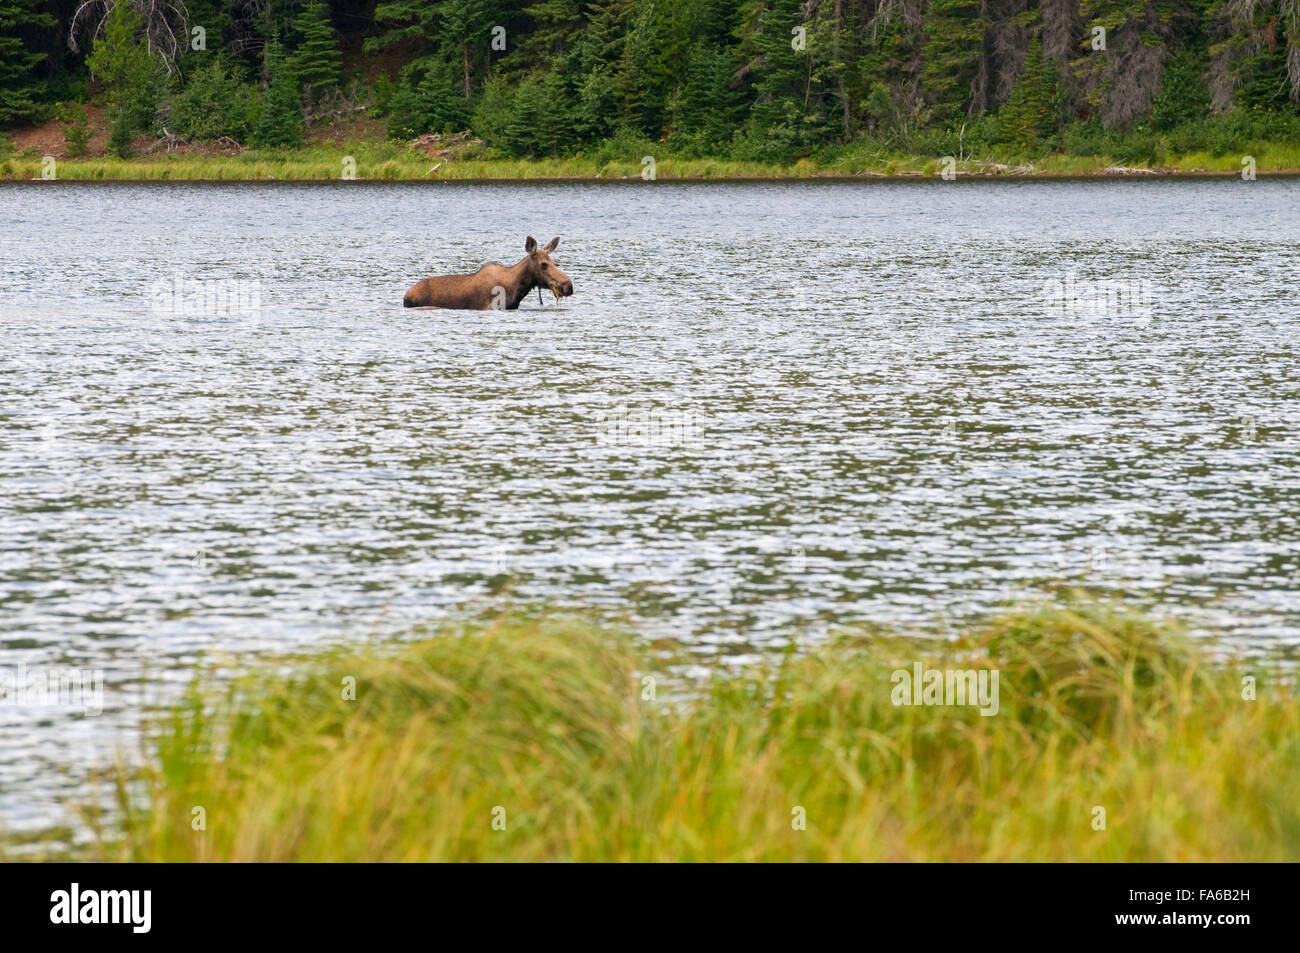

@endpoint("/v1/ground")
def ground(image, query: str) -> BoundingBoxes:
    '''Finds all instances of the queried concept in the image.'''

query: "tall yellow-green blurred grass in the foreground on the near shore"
[32,605,1300,861]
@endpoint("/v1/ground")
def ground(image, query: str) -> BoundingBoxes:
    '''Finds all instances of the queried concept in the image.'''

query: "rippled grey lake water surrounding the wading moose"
[0,179,1300,827]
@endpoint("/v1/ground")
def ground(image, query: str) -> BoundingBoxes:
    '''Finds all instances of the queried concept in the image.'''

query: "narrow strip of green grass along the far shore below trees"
[0,142,1300,182]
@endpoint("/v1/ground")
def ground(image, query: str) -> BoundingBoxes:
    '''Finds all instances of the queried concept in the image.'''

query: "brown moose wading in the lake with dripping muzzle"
[402,235,573,311]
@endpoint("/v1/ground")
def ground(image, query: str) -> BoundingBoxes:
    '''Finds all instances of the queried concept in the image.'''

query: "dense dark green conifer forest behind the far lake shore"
[0,0,1300,163]
